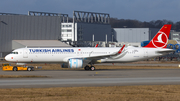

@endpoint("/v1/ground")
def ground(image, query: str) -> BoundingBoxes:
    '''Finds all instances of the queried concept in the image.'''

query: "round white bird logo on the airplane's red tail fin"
[152,31,168,48]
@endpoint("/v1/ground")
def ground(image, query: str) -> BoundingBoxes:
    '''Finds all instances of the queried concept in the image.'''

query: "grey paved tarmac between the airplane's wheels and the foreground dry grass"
[0,68,180,88]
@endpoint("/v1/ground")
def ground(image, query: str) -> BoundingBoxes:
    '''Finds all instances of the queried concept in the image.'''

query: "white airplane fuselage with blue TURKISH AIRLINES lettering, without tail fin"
[5,47,171,63]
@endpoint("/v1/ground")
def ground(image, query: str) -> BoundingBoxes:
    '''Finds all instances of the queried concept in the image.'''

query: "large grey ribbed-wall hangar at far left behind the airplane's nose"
[0,12,67,57]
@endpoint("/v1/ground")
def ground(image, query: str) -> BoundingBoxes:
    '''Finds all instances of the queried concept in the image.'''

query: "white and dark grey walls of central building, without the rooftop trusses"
[61,23,111,41]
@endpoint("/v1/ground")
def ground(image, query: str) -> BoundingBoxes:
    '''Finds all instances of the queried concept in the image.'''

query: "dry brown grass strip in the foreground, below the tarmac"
[0,85,180,101]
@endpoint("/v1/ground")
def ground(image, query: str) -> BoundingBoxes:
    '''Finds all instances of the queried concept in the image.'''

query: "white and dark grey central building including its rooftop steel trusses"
[61,11,111,41]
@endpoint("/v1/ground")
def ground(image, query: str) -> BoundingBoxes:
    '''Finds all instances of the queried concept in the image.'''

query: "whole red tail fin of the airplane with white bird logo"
[144,24,171,48]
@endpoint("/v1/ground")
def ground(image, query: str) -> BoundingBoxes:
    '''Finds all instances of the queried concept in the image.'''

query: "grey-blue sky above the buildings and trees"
[0,0,180,22]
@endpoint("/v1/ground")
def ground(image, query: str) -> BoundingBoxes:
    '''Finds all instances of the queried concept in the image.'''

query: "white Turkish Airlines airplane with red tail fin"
[5,24,174,71]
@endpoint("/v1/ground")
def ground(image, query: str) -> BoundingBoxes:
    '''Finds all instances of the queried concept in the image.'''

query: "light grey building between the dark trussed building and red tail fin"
[113,28,159,43]
